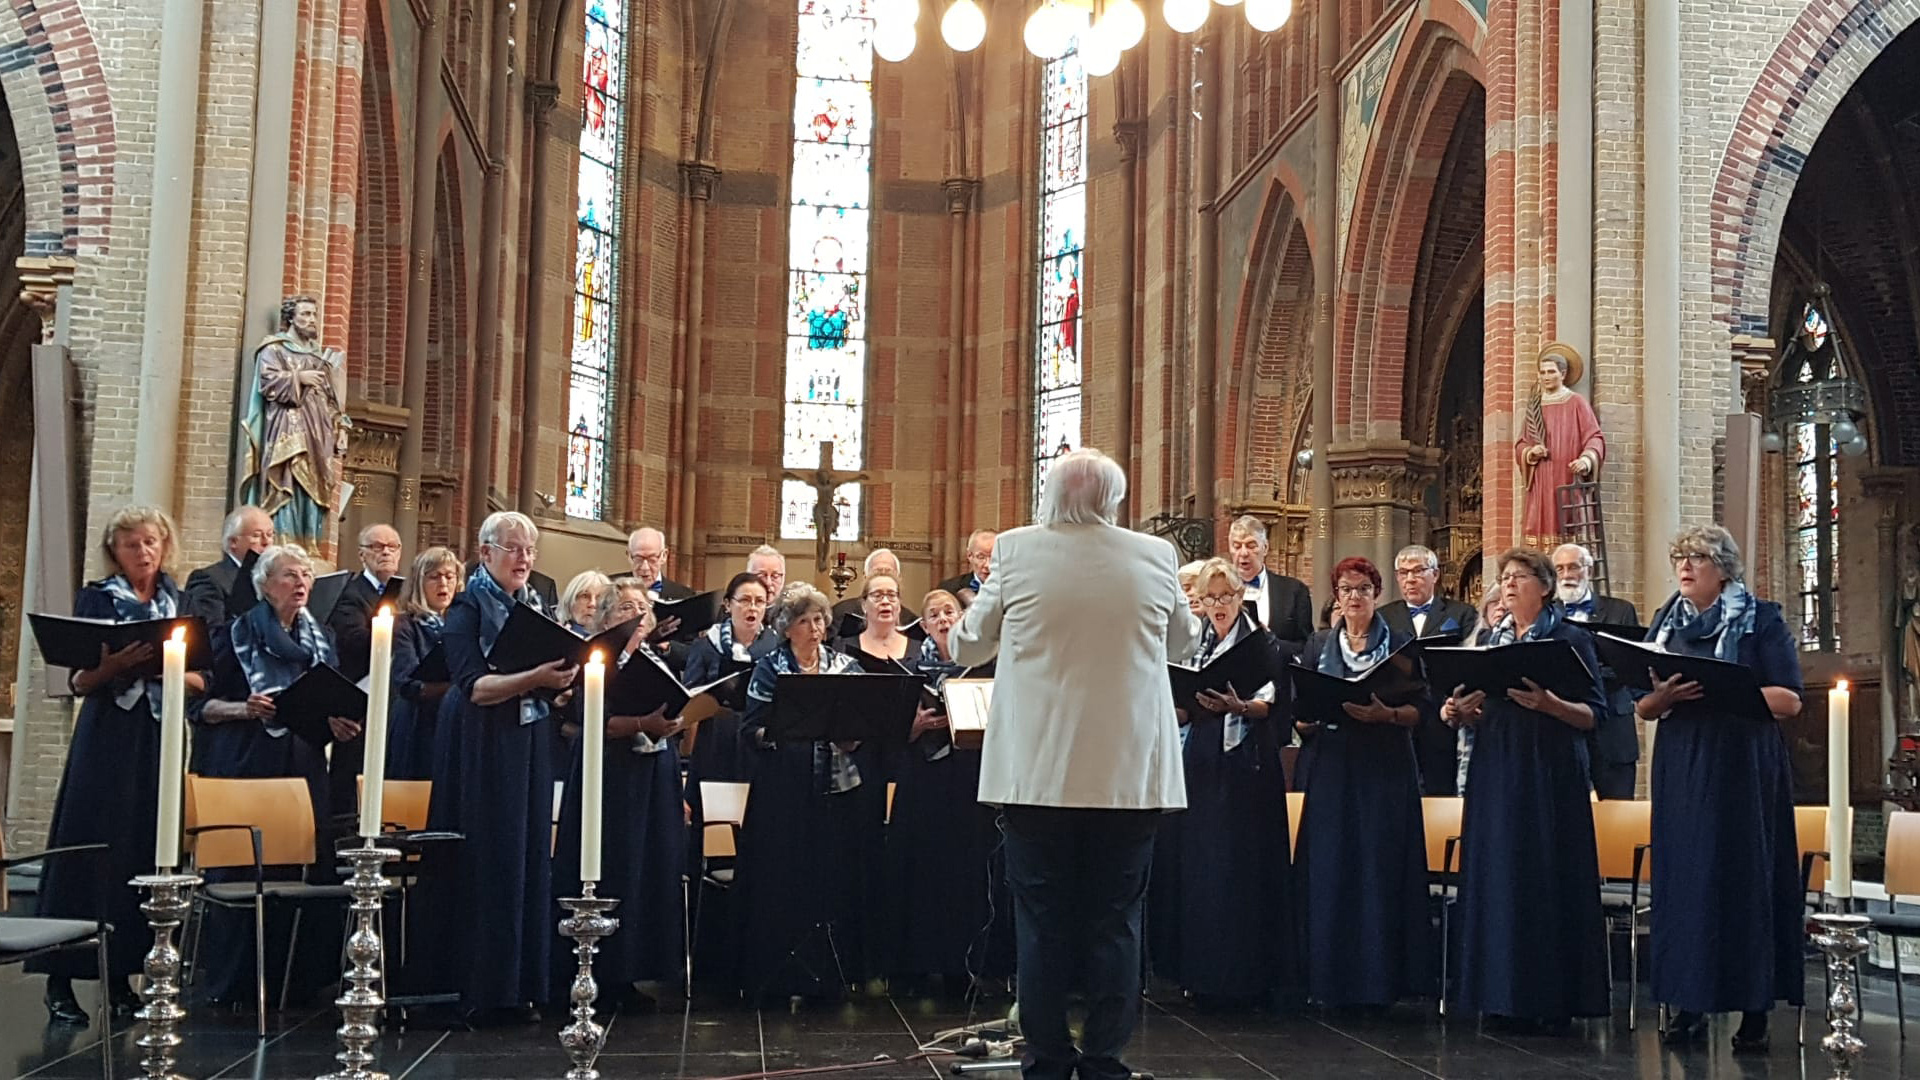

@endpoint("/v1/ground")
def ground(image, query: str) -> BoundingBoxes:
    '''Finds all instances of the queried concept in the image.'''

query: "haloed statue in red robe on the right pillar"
[1513,344,1607,548]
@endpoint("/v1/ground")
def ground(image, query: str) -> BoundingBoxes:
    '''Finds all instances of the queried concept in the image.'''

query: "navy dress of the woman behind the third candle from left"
[547,657,687,1001]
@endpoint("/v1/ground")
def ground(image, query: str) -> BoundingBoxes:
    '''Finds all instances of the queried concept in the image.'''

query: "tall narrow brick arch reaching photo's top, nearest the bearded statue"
[348,4,407,405]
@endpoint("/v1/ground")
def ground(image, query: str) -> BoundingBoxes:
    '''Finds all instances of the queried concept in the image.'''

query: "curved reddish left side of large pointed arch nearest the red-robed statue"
[1334,17,1486,442]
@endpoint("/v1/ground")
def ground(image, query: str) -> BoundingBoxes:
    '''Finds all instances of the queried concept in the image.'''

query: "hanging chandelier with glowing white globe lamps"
[872,0,1294,77]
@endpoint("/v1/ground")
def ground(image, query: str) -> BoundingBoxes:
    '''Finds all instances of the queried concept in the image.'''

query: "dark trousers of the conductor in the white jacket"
[1002,805,1160,1080]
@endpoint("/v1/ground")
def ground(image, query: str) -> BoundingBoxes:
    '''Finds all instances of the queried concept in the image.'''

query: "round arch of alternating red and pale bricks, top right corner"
[1707,0,1920,336]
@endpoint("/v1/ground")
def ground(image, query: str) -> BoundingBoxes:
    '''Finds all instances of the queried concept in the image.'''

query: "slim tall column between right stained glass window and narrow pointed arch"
[1192,30,1227,522]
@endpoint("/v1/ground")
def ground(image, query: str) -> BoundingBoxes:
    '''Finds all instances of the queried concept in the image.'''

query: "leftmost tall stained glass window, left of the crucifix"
[566,0,626,517]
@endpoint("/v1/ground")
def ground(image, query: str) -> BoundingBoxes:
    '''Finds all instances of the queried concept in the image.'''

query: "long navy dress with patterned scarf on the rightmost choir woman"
[1649,582,1807,1013]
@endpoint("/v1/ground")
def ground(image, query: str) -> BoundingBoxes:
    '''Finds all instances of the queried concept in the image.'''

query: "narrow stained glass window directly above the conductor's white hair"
[1033,42,1087,507]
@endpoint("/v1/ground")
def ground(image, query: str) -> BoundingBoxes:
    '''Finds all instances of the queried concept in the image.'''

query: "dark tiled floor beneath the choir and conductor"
[0,969,1920,1080]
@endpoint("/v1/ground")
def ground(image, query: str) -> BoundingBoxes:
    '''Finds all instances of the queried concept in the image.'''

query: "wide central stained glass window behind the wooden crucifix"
[780,0,874,542]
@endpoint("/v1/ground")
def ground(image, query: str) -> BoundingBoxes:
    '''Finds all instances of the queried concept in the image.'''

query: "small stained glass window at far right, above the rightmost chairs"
[1788,304,1839,651]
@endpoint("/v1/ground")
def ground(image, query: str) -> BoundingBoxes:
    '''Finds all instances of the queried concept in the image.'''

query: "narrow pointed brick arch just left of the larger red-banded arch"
[1225,177,1313,502]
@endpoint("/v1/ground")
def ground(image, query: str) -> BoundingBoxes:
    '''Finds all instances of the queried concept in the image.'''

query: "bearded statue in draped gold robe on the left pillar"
[240,296,353,553]
